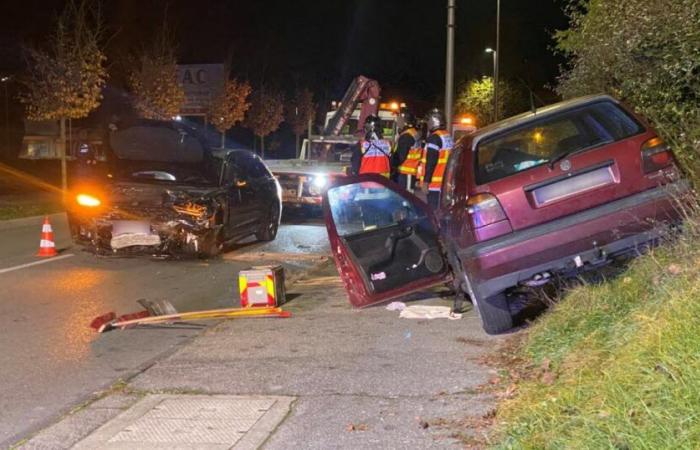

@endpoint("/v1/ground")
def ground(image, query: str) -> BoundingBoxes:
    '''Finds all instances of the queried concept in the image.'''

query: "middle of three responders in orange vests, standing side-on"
[394,109,423,192]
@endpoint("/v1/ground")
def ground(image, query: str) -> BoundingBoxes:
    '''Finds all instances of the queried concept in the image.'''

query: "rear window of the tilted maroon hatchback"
[476,101,644,184]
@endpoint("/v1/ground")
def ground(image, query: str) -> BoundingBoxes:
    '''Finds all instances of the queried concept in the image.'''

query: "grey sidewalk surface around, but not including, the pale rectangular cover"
[20,265,501,449]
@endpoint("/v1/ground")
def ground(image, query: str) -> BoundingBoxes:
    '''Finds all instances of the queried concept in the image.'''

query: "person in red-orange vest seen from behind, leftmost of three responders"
[351,116,391,178]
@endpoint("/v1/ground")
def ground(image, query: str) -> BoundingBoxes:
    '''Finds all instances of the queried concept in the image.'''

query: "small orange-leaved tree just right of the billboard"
[209,78,251,148]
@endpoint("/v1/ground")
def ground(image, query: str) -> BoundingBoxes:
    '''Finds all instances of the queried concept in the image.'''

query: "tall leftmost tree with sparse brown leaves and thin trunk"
[20,0,107,192]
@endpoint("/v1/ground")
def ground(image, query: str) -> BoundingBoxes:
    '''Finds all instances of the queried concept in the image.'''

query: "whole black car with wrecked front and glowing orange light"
[67,121,282,257]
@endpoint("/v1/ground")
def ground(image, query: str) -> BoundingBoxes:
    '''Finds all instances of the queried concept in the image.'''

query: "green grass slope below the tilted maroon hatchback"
[497,219,700,449]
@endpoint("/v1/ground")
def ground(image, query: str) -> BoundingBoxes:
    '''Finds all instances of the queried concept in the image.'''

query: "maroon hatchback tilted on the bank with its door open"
[324,95,688,333]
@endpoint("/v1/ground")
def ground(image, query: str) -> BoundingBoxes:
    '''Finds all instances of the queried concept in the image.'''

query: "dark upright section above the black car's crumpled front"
[110,125,218,185]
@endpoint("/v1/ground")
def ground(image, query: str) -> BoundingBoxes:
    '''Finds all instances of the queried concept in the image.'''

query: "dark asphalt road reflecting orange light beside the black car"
[0,215,328,448]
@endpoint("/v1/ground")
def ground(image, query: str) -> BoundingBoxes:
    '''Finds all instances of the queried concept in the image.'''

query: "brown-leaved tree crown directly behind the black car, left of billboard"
[128,19,185,120]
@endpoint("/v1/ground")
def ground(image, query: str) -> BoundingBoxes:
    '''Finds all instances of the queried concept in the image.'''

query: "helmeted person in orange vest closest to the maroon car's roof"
[422,108,453,208]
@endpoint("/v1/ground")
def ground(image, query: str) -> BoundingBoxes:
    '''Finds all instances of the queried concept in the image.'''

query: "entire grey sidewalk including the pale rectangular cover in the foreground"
[20,263,500,449]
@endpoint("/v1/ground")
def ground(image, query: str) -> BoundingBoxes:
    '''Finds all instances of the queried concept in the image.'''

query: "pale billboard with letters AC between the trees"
[177,64,225,116]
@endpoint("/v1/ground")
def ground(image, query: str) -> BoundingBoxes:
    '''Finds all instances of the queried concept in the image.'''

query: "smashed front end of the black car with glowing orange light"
[67,121,228,255]
